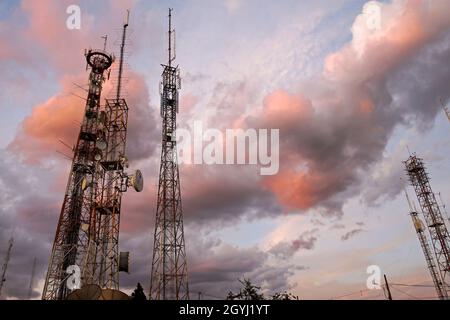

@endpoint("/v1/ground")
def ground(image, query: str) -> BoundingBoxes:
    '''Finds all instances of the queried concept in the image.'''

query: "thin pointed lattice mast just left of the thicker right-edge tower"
[405,189,448,300]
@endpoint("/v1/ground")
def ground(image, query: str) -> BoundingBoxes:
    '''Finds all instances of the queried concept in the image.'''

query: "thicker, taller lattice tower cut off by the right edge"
[405,155,450,297]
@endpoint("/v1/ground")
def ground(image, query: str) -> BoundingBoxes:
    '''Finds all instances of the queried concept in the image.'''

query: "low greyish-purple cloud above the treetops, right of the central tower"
[187,232,305,299]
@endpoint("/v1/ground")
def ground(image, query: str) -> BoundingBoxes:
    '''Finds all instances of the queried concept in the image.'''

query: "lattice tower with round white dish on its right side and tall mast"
[84,11,143,290]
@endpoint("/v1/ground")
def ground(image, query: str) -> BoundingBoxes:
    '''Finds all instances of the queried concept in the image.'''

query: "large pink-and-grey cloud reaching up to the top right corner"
[244,1,450,215]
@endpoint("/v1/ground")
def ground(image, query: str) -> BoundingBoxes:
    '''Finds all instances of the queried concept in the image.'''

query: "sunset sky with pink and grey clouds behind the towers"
[0,0,450,299]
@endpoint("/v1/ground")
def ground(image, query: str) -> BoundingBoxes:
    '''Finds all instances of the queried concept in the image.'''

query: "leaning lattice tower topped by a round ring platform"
[42,50,114,300]
